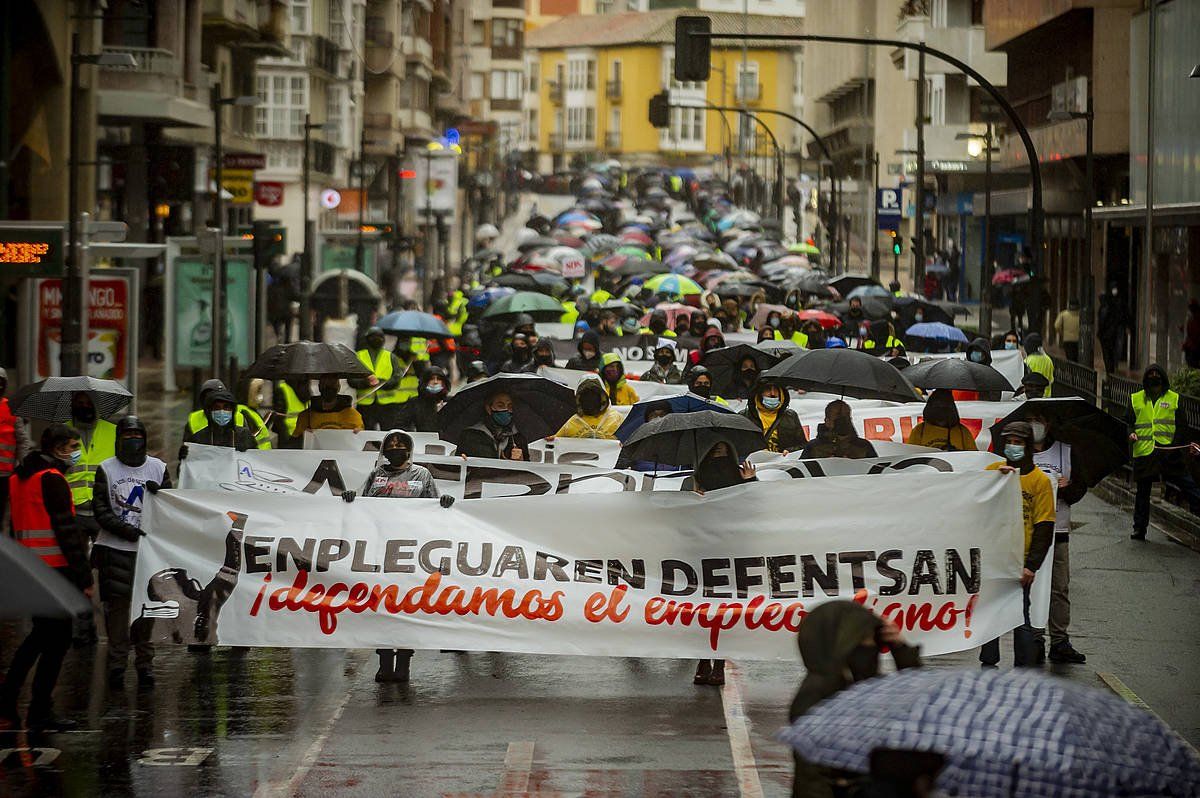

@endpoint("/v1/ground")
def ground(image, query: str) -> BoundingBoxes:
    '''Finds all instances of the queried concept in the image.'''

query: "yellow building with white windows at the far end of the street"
[526,8,804,170]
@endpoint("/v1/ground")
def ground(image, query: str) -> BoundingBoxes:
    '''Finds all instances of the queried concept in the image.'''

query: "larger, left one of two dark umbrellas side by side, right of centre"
[760,349,917,402]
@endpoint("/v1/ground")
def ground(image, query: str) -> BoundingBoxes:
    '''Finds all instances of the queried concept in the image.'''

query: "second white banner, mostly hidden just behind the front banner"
[179,445,1000,499]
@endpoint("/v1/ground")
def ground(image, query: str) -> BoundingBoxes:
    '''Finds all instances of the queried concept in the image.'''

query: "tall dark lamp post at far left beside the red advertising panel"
[62,31,137,377]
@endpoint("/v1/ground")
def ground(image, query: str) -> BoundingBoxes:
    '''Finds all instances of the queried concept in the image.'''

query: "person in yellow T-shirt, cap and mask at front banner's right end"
[979,421,1055,667]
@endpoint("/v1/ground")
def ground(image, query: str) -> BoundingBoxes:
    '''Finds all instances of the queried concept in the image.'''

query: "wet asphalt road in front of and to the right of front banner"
[0,489,1200,798]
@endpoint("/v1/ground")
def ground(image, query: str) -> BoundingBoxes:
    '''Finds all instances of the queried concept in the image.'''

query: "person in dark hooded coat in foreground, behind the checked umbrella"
[787,600,920,798]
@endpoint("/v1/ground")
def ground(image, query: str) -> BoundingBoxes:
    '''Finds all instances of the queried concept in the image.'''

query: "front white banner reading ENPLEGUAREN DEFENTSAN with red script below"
[133,472,1022,661]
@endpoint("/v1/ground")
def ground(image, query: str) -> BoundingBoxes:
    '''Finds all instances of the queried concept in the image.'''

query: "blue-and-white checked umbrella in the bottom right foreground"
[780,668,1200,798]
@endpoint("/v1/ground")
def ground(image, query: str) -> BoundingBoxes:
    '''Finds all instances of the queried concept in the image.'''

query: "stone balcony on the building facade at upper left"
[96,46,212,127]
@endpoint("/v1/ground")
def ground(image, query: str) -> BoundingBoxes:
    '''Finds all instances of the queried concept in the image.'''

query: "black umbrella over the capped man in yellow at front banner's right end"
[991,396,1129,487]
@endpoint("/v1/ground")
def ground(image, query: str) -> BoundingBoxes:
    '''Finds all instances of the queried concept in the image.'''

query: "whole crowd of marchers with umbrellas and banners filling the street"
[0,164,1200,797]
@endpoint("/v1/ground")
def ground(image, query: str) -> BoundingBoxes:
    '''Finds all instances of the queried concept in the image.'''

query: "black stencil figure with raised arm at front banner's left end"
[131,510,247,646]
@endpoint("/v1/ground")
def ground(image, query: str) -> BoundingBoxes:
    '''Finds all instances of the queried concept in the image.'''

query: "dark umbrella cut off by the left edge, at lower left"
[0,536,91,618]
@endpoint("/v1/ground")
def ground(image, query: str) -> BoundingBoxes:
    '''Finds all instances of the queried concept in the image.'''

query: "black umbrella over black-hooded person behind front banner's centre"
[617,410,767,468]
